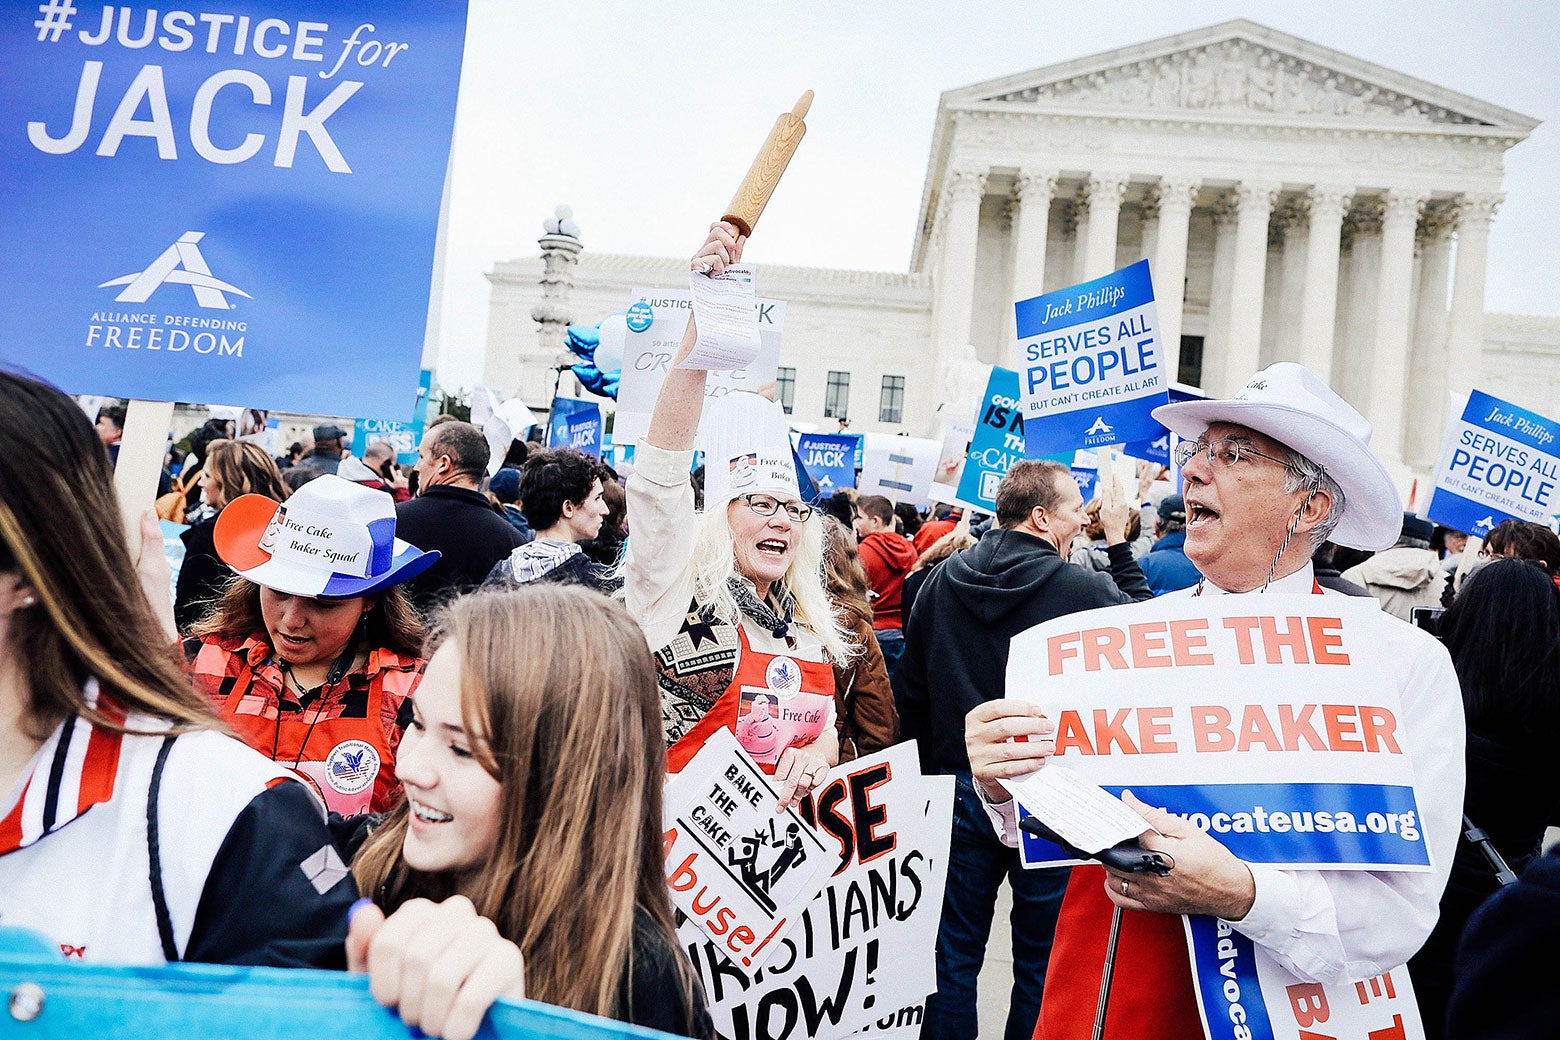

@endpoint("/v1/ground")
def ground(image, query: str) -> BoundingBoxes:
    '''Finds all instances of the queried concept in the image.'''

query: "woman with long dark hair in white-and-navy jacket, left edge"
[0,371,356,967]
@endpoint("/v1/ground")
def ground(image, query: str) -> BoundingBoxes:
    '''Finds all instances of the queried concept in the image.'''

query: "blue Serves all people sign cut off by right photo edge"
[1424,390,1560,538]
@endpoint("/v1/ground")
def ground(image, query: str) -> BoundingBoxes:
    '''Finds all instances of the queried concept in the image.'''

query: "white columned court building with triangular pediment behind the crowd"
[487,20,1560,491]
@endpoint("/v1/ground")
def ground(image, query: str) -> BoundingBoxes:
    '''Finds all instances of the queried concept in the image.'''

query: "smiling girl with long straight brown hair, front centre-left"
[348,583,711,1037]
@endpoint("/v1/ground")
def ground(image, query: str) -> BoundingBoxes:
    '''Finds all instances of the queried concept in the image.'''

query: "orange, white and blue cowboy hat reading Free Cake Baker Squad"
[214,474,438,599]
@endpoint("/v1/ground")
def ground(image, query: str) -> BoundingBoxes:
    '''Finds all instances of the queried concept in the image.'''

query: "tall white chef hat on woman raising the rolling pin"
[699,391,802,510]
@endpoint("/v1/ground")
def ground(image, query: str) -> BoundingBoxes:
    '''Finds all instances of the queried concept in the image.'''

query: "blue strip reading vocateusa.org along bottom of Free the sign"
[1019,784,1431,867]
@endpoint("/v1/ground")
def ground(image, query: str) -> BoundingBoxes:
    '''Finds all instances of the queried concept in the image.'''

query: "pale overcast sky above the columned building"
[438,0,1560,387]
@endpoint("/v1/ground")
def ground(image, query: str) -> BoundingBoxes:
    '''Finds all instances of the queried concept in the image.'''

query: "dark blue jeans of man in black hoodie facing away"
[920,770,1069,1040]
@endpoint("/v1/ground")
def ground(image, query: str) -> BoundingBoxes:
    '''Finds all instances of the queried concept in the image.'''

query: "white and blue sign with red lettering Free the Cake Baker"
[1008,594,1431,870]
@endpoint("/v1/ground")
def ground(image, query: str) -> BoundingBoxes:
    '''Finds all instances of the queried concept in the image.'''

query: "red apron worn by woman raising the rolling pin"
[666,625,835,773]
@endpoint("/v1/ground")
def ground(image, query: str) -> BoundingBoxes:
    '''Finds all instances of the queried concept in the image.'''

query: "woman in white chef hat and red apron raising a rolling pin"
[622,221,855,806]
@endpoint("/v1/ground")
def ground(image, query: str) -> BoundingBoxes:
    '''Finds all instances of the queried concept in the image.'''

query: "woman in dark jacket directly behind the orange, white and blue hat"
[173,440,292,631]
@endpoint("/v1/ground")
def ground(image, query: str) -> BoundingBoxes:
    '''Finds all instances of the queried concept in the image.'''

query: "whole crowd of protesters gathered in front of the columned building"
[0,225,1560,1040]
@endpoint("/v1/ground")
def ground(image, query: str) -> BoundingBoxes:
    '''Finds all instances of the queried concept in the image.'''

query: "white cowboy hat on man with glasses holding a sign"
[1154,362,1402,550]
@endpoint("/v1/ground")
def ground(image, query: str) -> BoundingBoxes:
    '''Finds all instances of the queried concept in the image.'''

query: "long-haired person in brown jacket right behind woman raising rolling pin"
[824,516,899,762]
